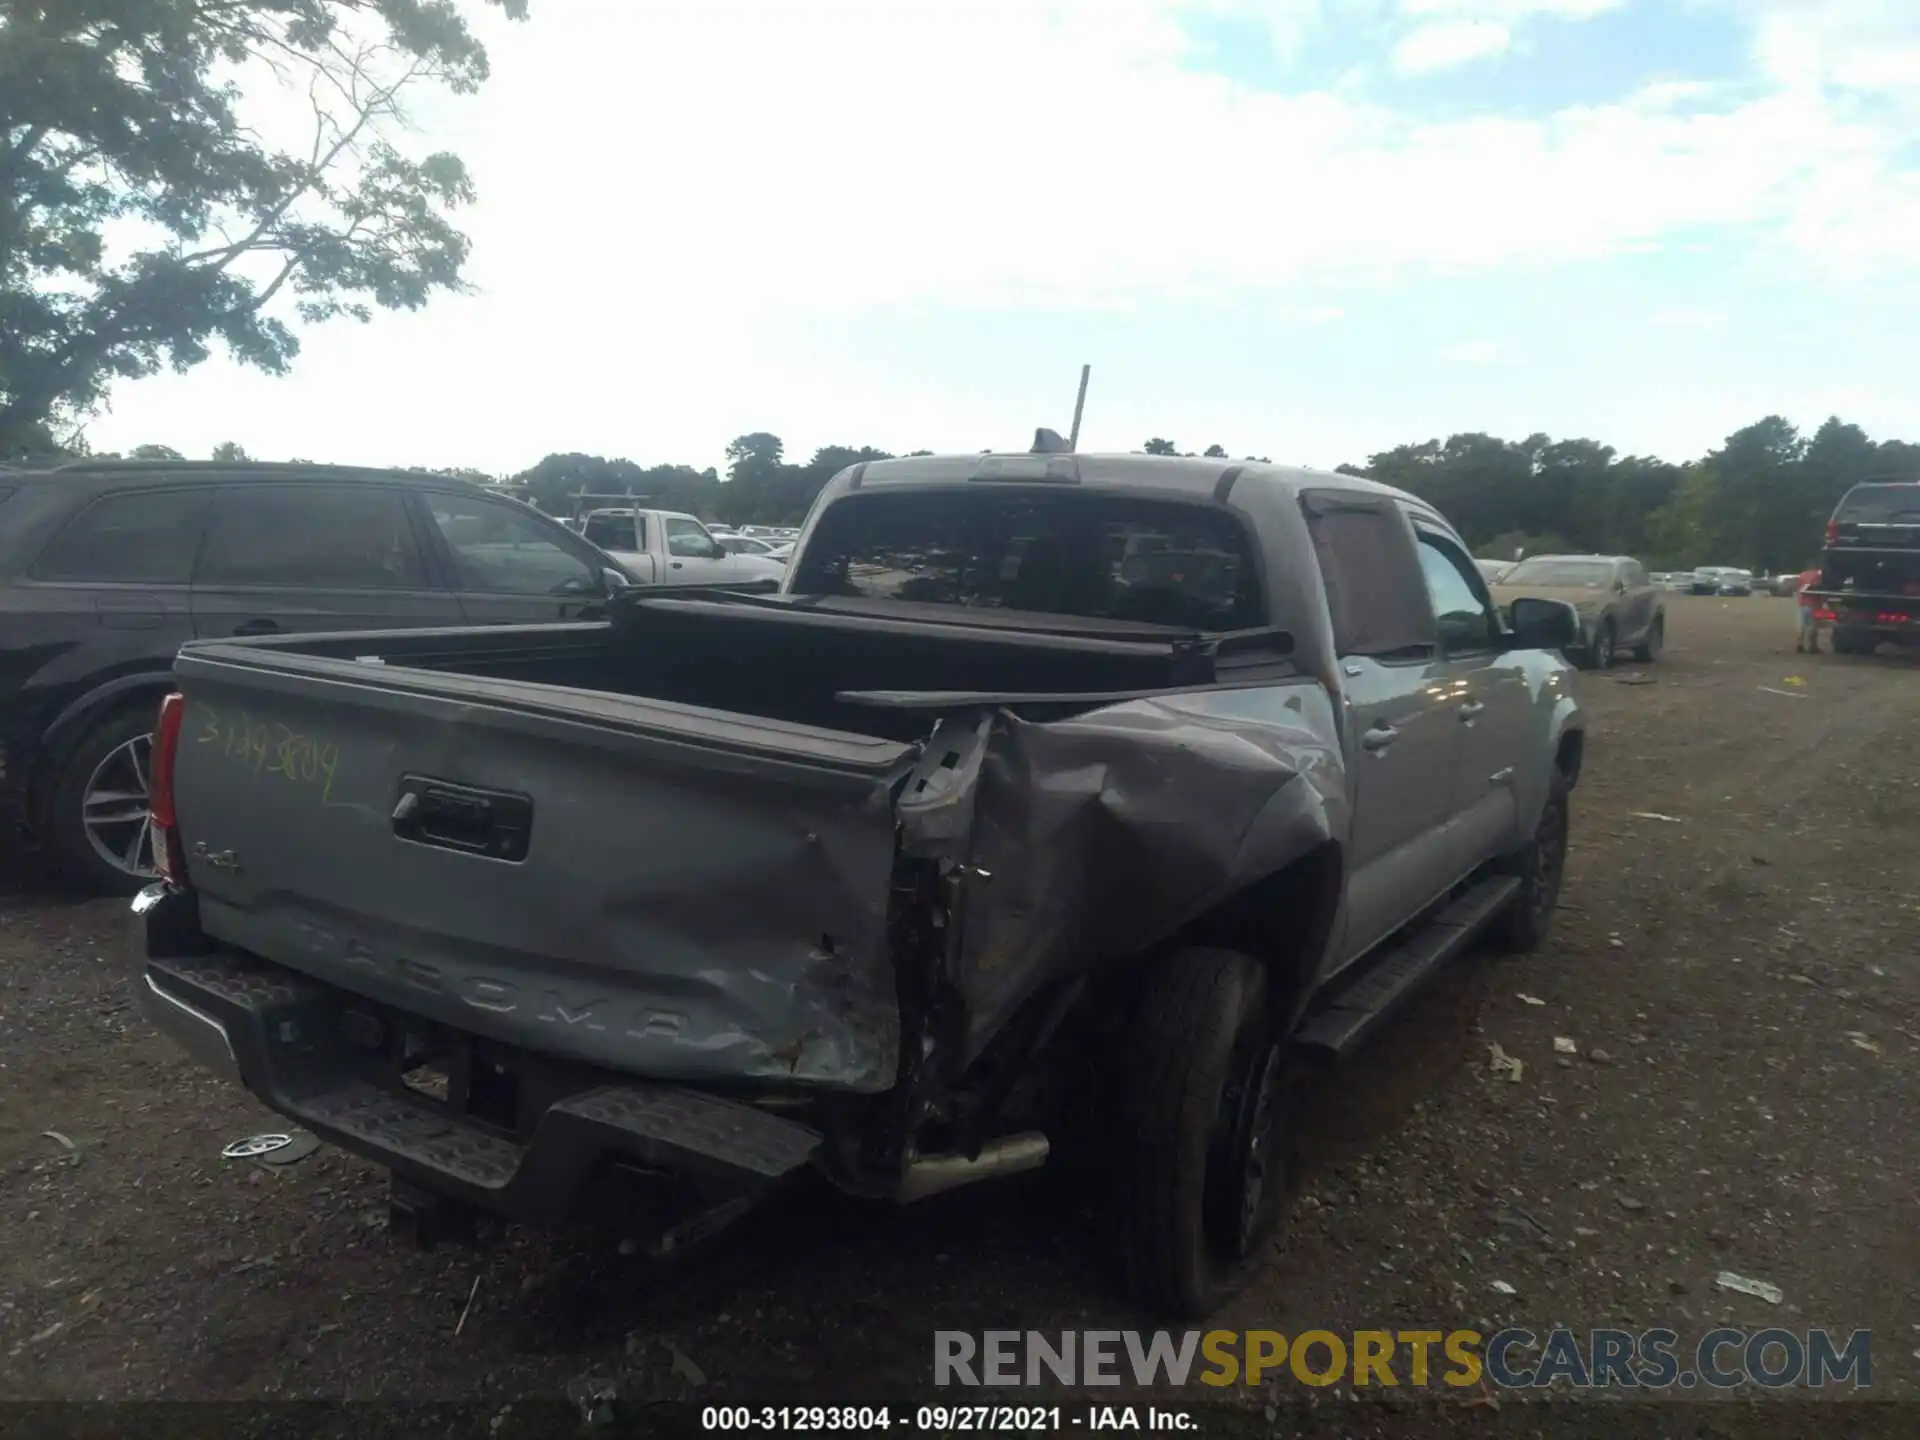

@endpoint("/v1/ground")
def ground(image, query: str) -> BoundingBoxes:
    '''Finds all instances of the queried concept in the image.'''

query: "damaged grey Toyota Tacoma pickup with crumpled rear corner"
[134,453,1584,1315]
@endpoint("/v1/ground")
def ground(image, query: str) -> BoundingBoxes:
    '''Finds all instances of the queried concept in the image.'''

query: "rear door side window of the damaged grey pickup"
[1302,493,1434,659]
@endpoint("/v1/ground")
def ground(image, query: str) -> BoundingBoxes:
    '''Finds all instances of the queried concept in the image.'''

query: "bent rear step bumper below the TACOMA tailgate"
[132,885,820,1223]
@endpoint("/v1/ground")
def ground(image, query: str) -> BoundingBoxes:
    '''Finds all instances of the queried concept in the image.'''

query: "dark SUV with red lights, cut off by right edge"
[1809,482,1920,655]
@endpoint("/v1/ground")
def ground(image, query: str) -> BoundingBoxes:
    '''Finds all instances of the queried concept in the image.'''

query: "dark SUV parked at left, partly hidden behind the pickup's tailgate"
[0,461,630,893]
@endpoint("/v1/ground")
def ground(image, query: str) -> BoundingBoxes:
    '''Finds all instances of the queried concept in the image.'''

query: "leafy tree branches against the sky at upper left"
[0,0,526,444]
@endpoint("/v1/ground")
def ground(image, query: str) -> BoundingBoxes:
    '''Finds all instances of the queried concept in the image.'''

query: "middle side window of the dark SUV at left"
[194,482,426,589]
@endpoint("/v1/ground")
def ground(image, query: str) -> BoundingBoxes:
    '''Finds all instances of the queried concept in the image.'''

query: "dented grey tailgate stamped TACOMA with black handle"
[175,645,912,1091]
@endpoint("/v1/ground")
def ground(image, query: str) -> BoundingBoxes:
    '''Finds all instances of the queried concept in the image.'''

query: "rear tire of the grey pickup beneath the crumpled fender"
[1114,948,1294,1319]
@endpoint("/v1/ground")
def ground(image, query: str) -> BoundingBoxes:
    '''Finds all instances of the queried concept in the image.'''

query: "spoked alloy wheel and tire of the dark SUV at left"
[46,699,159,895]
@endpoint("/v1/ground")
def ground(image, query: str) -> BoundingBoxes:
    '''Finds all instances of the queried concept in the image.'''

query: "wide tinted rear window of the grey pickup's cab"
[793,488,1263,630]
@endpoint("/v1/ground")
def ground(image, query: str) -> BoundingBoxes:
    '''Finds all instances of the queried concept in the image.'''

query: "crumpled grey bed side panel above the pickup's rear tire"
[900,682,1348,1064]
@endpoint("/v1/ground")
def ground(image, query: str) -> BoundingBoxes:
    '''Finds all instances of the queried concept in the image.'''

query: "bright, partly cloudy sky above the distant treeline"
[88,0,1920,472]
